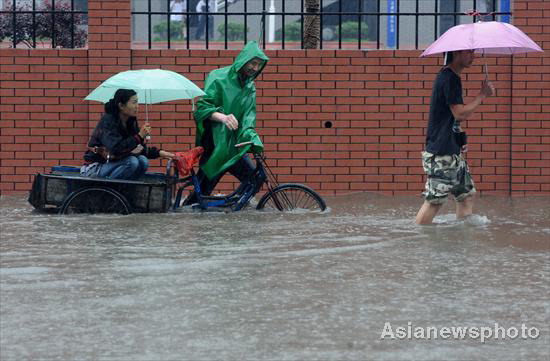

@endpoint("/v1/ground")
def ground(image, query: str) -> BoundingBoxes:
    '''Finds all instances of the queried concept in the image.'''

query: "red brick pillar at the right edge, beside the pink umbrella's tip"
[511,0,550,195]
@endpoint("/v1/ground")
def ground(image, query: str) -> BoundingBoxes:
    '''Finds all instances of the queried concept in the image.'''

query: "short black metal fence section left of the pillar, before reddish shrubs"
[0,0,88,48]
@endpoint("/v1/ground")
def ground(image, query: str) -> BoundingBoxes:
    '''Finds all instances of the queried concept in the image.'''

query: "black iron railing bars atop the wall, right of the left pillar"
[132,0,511,49]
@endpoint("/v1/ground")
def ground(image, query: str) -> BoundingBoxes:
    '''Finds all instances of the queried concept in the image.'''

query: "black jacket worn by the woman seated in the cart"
[84,113,159,163]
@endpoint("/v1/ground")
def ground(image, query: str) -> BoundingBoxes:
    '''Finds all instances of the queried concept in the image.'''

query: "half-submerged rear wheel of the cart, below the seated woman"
[59,188,132,214]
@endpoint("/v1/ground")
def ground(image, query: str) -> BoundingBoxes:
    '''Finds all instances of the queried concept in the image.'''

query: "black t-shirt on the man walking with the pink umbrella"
[426,68,464,155]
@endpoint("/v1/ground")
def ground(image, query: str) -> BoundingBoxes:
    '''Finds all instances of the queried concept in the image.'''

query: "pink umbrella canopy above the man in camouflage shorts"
[420,21,543,57]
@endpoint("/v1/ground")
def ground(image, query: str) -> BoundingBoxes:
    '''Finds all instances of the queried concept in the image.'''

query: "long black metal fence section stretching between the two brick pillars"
[132,0,511,49]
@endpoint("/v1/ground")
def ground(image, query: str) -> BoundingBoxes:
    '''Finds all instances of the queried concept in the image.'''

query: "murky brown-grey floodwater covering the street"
[0,193,550,361]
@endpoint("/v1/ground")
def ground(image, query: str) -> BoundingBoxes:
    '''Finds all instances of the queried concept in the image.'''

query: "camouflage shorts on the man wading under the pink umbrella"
[422,152,476,204]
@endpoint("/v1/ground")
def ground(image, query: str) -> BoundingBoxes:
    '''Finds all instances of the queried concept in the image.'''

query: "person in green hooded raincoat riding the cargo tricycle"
[185,41,269,204]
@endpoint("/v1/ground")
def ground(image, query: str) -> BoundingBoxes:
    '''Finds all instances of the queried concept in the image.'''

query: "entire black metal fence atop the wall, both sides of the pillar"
[0,0,511,49]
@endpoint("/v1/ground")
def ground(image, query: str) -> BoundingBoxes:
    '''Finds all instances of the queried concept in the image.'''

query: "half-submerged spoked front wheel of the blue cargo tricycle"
[256,183,327,212]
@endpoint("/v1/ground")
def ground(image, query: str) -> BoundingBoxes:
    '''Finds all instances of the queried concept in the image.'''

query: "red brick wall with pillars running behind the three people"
[0,0,550,195]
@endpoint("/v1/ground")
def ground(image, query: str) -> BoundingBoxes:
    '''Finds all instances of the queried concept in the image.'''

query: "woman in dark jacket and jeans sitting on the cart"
[80,89,174,180]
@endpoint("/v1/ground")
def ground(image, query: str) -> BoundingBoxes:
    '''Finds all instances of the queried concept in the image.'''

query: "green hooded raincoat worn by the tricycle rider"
[193,41,269,179]
